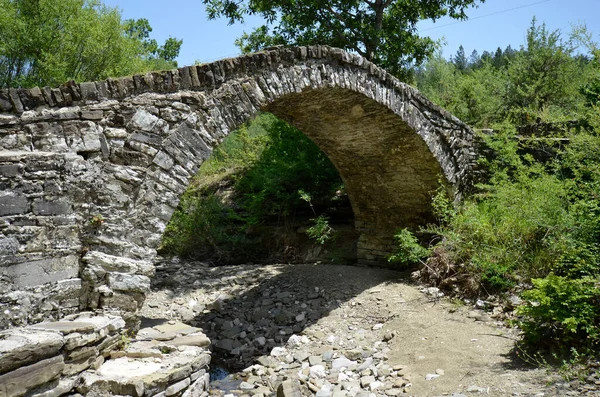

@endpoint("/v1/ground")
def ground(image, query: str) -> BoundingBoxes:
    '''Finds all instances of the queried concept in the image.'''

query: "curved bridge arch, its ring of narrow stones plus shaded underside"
[124,48,472,264]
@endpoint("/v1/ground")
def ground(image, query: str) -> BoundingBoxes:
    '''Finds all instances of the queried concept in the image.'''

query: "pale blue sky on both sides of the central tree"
[104,0,600,66]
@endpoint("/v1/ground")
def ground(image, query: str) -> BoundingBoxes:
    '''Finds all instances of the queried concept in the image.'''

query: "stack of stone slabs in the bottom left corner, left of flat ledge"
[0,313,125,397]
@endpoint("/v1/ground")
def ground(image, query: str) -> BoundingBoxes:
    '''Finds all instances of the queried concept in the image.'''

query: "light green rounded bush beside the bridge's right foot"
[431,168,572,292]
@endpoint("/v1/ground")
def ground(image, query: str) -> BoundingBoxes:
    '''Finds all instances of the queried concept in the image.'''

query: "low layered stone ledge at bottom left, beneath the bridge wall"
[0,313,210,397]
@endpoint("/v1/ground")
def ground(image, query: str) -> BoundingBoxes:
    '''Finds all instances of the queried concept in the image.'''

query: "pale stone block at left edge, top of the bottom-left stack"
[0,328,65,374]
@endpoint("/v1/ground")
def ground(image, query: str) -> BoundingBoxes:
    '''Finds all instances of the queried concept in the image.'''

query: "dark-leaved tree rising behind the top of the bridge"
[202,0,484,76]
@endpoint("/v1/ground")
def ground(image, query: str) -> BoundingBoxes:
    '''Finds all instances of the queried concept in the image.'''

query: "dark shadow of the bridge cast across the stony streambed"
[145,262,408,370]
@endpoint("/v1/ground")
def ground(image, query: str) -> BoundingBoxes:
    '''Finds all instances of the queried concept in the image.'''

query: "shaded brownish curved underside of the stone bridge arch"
[267,88,444,265]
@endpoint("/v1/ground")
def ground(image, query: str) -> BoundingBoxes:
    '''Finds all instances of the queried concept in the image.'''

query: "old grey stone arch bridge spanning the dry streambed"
[0,46,476,328]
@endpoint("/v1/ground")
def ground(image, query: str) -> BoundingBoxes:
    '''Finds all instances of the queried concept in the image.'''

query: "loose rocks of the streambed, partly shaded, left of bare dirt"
[143,260,411,397]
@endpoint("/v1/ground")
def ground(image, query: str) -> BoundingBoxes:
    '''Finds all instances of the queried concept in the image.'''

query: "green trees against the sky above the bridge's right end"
[416,18,588,124]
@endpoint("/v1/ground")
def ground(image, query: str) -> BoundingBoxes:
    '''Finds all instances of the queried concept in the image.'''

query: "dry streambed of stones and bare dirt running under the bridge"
[143,262,598,397]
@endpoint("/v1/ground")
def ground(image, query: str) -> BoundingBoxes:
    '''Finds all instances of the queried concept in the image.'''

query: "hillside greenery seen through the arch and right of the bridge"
[162,20,600,354]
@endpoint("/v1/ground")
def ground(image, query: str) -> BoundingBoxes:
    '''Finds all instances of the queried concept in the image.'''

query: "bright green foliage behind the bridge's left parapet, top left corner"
[0,0,181,87]
